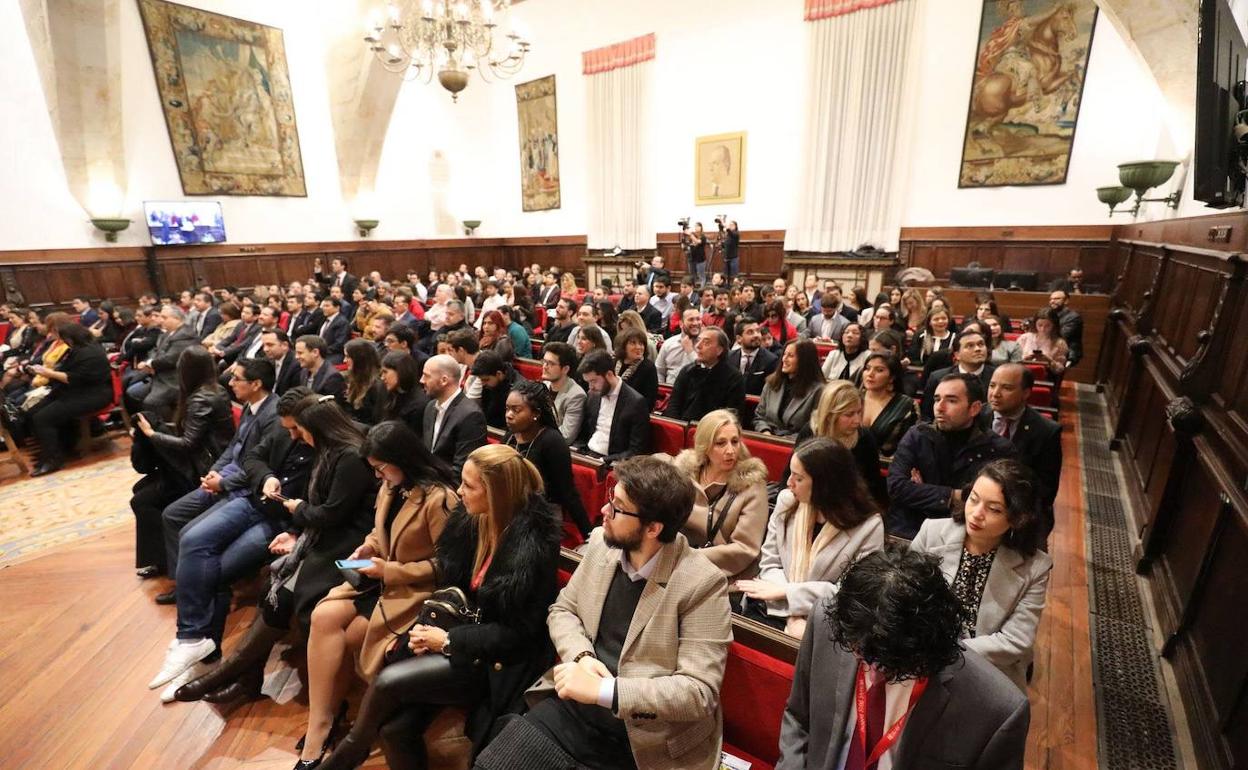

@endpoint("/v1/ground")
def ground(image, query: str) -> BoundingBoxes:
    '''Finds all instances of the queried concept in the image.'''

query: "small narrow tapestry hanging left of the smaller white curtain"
[515,75,559,211]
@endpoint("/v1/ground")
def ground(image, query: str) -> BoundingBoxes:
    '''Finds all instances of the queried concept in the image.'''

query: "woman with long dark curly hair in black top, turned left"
[503,379,593,540]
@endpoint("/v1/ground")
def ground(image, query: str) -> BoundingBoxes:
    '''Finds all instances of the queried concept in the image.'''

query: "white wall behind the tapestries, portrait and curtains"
[0,0,1228,250]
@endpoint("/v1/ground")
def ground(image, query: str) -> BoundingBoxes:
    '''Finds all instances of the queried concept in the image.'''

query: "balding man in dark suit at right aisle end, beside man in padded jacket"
[986,363,1062,538]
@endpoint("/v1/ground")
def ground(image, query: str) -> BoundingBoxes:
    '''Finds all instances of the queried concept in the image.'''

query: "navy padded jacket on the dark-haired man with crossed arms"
[885,422,1018,539]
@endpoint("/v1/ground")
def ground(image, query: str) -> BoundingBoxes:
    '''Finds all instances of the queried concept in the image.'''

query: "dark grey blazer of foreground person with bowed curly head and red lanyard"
[776,608,1031,770]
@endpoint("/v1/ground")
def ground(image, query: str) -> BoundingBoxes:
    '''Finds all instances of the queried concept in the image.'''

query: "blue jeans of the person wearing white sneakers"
[177,497,281,645]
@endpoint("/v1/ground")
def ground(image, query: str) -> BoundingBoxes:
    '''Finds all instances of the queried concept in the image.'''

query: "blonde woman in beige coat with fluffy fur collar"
[663,409,768,582]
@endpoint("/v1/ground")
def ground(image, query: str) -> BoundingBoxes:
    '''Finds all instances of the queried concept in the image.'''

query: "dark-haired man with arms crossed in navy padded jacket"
[889,374,1017,539]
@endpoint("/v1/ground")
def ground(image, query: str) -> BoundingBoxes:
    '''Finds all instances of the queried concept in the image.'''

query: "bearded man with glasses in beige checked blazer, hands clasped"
[477,456,733,770]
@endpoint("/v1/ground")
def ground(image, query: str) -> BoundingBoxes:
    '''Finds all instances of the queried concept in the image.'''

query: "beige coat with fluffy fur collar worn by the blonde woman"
[673,449,768,583]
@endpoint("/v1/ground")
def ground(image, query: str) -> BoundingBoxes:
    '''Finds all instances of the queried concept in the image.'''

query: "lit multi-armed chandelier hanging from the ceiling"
[364,0,529,101]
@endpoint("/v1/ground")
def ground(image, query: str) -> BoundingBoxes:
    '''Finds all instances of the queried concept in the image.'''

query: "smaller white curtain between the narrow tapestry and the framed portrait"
[585,60,655,248]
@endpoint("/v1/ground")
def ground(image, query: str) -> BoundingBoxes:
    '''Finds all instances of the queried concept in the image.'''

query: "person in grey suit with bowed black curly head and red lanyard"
[776,550,1031,770]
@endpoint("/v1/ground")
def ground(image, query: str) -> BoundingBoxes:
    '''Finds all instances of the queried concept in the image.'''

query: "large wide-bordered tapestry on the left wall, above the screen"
[139,0,307,196]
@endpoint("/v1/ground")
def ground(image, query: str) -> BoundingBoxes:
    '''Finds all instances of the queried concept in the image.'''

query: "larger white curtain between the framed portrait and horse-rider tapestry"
[784,0,917,252]
